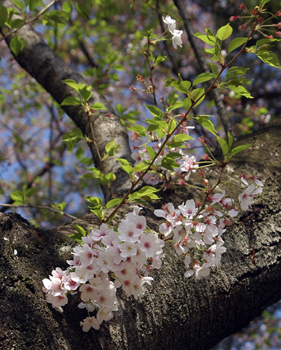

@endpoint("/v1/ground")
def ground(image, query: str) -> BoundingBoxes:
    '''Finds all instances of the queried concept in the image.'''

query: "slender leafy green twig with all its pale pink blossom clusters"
[43,1,280,332]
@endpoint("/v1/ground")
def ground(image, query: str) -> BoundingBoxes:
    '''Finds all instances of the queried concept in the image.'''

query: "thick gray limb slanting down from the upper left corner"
[0,0,132,199]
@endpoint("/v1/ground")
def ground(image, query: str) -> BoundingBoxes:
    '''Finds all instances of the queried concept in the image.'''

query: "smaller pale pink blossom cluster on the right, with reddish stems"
[154,174,263,279]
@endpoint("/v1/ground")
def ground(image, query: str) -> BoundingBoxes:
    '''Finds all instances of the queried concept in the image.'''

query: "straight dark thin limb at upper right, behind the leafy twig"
[174,0,233,136]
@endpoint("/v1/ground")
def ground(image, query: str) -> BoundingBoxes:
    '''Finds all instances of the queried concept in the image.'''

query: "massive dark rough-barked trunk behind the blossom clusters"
[0,123,281,350]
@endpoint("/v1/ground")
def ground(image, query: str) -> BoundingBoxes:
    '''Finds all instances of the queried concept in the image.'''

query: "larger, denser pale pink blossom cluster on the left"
[43,206,164,332]
